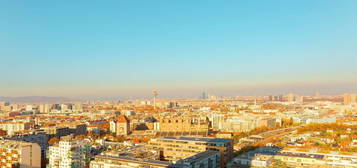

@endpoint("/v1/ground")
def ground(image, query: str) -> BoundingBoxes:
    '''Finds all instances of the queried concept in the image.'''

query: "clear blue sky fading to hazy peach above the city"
[0,0,357,97]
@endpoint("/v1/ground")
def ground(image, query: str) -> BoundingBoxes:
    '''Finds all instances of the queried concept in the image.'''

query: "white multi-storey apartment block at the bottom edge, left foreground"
[48,135,90,168]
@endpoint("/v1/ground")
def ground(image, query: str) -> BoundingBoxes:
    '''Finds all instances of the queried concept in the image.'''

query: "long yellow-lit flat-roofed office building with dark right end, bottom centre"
[148,137,233,167]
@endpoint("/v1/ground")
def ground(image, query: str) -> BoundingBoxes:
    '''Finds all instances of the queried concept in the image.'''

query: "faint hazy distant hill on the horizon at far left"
[0,96,71,103]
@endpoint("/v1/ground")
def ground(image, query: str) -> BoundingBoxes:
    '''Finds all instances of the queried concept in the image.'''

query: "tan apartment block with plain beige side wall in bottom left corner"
[0,140,41,168]
